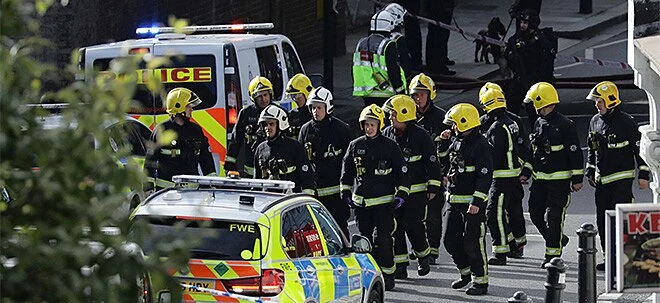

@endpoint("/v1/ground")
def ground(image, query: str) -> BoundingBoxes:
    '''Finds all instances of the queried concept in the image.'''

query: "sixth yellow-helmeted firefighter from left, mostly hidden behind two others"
[408,73,449,264]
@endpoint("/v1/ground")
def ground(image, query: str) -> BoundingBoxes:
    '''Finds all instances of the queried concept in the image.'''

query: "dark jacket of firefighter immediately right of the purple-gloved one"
[383,123,442,194]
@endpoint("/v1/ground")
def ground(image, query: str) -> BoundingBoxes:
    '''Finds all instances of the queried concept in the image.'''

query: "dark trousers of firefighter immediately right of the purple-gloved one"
[394,192,431,266]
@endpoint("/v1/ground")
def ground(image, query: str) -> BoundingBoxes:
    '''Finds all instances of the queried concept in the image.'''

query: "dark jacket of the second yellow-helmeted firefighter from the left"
[225,104,266,176]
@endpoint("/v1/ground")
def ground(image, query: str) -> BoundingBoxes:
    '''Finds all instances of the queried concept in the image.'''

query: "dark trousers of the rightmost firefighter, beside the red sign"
[596,179,635,252]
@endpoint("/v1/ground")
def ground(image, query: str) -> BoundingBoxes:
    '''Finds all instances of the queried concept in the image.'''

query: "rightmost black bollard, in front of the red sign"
[576,223,598,303]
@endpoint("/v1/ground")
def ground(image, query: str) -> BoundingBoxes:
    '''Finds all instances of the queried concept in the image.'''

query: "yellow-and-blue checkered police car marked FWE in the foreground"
[132,175,384,303]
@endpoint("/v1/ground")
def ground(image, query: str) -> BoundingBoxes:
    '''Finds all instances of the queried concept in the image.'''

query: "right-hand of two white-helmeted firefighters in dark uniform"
[298,86,353,237]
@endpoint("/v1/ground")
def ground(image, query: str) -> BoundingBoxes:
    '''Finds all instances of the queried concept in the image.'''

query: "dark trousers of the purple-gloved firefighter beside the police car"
[355,203,396,275]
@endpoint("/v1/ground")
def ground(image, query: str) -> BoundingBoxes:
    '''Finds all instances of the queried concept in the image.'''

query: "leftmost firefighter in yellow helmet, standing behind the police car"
[145,87,216,190]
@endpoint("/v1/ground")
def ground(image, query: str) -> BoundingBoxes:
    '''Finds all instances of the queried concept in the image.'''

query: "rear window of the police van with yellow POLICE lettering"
[93,55,222,114]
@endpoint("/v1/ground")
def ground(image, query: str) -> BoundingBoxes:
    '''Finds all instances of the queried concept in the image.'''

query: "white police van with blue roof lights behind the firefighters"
[78,23,312,175]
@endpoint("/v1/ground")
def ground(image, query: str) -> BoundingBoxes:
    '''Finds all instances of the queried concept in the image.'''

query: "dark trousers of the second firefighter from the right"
[529,180,571,258]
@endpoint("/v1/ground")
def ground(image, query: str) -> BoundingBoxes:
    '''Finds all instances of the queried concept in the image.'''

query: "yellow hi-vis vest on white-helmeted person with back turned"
[353,34,406,98]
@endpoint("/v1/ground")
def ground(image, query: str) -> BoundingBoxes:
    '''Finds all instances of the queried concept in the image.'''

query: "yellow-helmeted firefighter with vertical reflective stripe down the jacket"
[479,88,526,265]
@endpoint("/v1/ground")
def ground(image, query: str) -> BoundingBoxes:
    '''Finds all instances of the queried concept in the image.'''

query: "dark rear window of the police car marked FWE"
[136,216,263,261]
